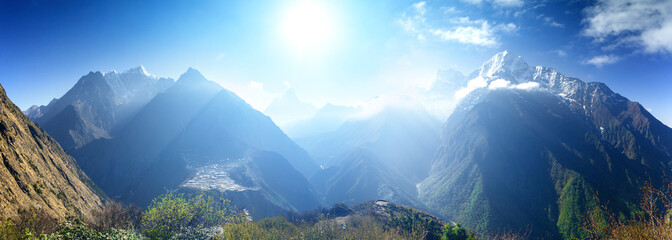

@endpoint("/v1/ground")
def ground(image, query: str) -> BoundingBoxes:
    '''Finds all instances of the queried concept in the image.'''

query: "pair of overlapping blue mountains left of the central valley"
[27,67,321,216]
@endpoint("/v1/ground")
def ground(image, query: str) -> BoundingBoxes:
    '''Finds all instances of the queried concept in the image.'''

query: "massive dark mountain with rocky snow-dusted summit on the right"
[419,52,672,239]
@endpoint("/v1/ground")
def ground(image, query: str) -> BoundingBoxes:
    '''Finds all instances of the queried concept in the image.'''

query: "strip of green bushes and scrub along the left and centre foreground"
[0,191,532,240]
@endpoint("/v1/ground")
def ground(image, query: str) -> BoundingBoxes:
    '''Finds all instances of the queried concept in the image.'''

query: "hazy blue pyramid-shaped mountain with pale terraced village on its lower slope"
[65,68,319,215]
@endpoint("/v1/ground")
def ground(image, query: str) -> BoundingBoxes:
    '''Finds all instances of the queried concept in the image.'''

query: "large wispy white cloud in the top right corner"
[583,0,672,53]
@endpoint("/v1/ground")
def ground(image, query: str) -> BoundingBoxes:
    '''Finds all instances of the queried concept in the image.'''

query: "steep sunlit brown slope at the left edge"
[0,83,105,219]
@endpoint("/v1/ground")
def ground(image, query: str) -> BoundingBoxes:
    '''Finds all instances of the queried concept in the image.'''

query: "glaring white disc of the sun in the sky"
[283,1,334,52]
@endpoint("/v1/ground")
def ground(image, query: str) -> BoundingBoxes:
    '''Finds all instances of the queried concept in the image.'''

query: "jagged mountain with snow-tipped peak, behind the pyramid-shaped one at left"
[25,66,174,150]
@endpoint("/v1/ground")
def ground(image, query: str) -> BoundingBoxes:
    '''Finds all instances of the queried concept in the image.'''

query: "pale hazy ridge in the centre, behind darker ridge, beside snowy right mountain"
[297,105,441,182]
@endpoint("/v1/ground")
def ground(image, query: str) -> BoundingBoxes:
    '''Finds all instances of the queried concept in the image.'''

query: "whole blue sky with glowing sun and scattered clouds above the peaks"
[0,0,672,126]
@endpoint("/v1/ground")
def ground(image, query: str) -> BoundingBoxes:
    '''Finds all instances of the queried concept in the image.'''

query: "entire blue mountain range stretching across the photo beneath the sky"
[17,52,672,239]
